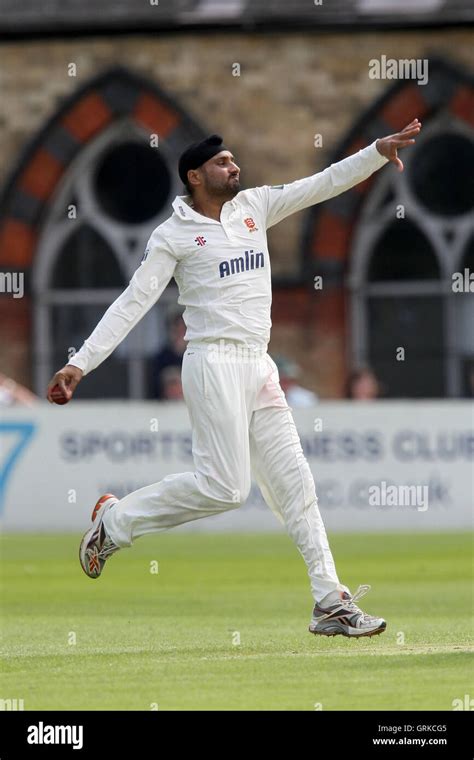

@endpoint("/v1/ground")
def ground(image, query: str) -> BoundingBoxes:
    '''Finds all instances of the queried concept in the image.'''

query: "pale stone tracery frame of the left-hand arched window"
[32,118,181,399]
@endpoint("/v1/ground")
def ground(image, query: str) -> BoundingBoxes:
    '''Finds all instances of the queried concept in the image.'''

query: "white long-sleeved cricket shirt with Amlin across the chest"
[69,141,388,375]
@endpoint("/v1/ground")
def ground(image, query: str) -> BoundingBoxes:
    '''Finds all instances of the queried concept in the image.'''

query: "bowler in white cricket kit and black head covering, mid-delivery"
[48,119,421,637]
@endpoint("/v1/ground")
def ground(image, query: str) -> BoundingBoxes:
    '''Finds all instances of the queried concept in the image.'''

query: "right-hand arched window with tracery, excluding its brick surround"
[349,114,474,397]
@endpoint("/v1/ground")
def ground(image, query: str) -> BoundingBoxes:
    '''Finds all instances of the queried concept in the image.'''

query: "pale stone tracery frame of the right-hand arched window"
[347,113,474,398]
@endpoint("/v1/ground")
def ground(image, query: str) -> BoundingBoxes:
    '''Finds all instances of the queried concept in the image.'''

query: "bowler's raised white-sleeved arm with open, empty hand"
[255,119,421,229]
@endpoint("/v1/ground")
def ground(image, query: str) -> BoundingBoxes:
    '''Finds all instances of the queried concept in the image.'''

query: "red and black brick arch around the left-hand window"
[0,67,205,383]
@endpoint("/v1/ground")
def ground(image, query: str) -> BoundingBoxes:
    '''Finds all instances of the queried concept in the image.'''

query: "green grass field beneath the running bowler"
[0,532,473,710]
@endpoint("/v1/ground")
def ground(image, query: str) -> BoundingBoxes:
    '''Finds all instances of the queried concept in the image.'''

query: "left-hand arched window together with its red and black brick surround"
[0,67,209,398]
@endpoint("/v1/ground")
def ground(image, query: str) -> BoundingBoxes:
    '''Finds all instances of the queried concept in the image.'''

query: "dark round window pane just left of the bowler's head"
[94,142,171,224]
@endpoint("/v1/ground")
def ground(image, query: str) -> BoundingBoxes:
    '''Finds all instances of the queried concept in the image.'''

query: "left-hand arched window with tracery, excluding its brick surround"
[34,120,181,398]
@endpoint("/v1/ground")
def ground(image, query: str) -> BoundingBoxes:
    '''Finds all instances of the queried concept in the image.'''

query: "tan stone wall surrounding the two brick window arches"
[0,28,474,397]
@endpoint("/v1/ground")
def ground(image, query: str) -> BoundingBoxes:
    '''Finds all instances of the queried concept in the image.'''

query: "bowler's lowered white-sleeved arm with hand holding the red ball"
[46,232,177,404]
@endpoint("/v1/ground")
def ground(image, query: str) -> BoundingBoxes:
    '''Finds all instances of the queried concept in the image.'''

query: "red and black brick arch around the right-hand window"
[302,59,474,397]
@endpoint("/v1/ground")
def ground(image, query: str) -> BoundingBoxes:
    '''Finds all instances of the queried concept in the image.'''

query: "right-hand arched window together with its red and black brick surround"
[302,58,474,398]
